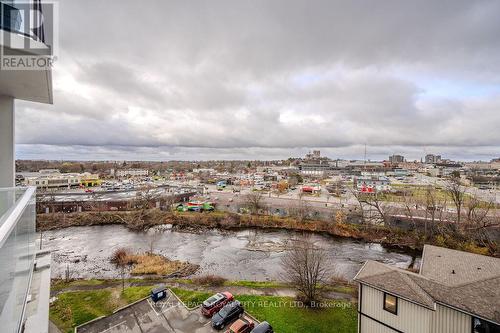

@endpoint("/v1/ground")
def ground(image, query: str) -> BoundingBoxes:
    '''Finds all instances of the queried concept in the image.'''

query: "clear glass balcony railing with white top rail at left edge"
[0,187,36,333]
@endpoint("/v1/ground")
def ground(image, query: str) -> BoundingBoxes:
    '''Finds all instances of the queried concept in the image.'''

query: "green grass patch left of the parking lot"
[49,289,118,332]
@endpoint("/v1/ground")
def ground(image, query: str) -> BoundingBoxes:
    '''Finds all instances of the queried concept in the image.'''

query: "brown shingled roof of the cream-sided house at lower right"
[355,245,500,323]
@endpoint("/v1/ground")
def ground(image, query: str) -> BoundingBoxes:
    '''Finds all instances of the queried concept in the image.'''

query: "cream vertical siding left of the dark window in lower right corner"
[431,304,472,333]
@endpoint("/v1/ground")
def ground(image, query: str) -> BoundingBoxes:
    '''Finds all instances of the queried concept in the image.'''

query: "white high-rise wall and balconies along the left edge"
[0,0,52,333]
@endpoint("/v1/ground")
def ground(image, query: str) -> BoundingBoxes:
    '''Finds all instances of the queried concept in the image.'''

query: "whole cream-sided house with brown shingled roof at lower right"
[354,245,500,333]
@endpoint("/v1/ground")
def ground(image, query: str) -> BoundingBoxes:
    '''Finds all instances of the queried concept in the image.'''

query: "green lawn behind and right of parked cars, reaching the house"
[172,288,357,333]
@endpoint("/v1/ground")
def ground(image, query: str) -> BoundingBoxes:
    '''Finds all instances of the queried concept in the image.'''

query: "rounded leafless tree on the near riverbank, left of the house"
[281,236,331,305]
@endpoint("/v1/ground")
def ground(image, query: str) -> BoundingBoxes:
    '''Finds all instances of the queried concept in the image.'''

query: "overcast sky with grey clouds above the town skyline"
[16,0,500,160]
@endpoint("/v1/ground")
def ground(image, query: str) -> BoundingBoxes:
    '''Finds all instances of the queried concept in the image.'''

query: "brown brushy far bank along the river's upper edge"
[37,209,424,254]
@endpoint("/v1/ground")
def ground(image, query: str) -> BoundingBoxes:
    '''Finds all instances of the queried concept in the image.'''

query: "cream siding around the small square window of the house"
[361,285,434,333]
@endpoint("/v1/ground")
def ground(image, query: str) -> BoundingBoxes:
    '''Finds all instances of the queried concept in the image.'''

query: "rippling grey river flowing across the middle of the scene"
[43,225,418,281]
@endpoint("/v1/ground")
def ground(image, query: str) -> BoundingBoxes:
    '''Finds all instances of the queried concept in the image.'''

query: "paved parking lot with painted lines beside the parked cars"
[76,292,258,333]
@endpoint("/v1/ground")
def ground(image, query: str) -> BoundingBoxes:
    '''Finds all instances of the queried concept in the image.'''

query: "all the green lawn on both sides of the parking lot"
[50,283,357,333]
